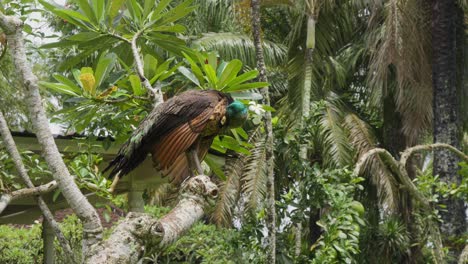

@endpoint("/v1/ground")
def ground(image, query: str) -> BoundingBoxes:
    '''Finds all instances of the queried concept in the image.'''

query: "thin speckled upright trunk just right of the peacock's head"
[252,0,276,263]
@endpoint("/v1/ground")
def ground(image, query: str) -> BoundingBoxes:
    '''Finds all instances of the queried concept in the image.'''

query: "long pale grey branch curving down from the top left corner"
[0,12,102,252]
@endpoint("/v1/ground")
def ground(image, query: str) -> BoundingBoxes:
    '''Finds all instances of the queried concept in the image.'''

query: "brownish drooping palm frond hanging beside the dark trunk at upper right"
[368,0,432,142]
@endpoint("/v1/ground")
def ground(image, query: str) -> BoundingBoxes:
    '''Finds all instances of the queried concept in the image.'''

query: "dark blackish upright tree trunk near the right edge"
[432,0,466,262]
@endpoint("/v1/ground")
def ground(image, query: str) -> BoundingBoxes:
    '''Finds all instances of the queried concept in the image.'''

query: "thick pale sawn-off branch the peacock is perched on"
[86,175,218,264]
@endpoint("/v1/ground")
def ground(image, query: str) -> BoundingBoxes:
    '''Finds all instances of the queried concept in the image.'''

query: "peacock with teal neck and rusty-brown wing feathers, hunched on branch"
[105,90,248,183]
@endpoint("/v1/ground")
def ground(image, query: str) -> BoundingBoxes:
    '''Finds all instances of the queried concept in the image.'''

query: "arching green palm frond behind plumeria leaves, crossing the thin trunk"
[192,33,286,68]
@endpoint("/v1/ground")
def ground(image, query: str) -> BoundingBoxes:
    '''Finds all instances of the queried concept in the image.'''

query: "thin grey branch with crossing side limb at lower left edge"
[0,111,76,263]
